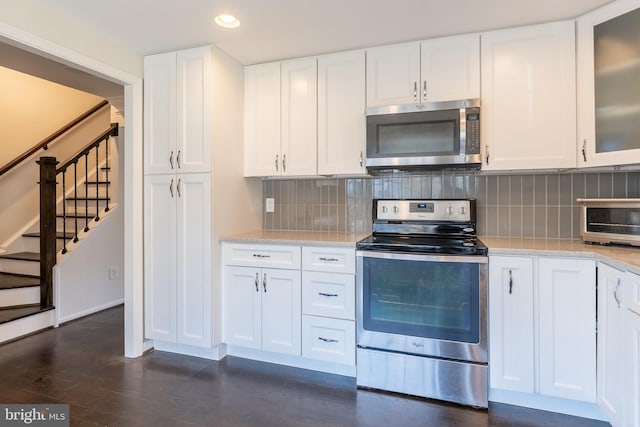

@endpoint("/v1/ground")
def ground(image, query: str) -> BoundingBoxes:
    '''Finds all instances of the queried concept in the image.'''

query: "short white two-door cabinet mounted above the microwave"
[367,34,480,107]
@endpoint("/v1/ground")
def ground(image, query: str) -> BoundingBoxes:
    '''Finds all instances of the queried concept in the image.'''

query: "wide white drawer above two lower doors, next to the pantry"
[222,243,300,269]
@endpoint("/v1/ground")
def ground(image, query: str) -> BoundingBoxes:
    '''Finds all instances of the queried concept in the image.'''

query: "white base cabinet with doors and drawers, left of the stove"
[222,243,356,372]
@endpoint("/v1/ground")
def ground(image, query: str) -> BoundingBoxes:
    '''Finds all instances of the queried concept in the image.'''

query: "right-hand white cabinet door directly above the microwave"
[420,34,480,102]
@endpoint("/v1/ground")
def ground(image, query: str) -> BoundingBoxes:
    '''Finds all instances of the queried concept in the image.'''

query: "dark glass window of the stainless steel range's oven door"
[362,257,480,343]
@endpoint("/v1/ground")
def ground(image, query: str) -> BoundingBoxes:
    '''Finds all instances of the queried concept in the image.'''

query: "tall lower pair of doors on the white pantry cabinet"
[144,174,211,347]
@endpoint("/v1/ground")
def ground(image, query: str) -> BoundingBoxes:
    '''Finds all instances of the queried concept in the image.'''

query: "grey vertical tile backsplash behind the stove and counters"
[263,171,640,239]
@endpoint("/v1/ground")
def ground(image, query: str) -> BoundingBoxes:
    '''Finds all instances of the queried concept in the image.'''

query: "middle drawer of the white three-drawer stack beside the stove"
[302,271,356,320]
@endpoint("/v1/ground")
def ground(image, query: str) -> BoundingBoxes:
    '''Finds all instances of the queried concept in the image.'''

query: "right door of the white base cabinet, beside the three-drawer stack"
[261,268,302,356]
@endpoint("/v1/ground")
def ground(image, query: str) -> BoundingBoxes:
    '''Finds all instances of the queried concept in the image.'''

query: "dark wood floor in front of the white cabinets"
[0,307,608,427]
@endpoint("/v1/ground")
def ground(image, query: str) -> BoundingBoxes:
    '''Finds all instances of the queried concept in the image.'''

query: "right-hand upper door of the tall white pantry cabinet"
[175,47,213,173]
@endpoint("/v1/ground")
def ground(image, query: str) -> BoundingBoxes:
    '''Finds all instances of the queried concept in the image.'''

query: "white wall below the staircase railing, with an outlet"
[53,207,124,323]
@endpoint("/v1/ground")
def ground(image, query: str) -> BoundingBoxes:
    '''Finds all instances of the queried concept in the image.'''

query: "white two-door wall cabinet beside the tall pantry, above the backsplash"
[244,58,317,176]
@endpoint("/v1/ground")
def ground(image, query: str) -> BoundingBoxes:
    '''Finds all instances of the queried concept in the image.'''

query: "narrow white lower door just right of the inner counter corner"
[598,264,629,426]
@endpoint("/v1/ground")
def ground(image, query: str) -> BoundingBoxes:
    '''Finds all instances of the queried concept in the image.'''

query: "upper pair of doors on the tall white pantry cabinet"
[144,47,212,174]
